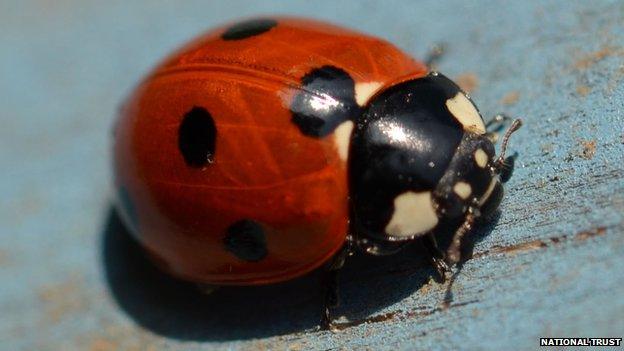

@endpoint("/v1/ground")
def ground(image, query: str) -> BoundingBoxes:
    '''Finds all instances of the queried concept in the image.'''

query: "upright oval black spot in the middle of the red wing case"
[178,107,217,167]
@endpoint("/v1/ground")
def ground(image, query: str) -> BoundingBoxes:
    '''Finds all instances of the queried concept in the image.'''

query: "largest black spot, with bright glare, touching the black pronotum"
[290,66,360,137]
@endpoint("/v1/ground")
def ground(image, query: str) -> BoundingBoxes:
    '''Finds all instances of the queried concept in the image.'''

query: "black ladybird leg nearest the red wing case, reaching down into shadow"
[320,235,353,330]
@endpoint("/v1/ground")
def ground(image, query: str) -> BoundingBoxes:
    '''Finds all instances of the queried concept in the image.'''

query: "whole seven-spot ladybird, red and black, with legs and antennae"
[113,18,520,328]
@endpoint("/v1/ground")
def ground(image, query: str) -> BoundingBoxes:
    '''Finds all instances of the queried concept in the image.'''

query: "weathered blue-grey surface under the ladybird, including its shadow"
[0,0,624,350]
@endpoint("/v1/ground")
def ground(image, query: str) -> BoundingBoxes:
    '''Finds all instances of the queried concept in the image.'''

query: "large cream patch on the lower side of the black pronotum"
[385,191,438,236]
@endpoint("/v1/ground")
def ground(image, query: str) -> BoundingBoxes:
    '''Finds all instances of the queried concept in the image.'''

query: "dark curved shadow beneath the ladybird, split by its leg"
[101,207,502,341]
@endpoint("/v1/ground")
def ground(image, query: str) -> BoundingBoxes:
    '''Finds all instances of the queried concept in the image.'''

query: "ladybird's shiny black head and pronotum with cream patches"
[349,73,520,253]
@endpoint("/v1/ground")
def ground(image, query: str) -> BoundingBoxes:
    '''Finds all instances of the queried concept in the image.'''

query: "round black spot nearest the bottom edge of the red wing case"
[223,219,268,262]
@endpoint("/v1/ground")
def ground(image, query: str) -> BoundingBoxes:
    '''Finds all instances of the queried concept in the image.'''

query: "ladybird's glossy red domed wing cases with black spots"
[114,18,427,285]
